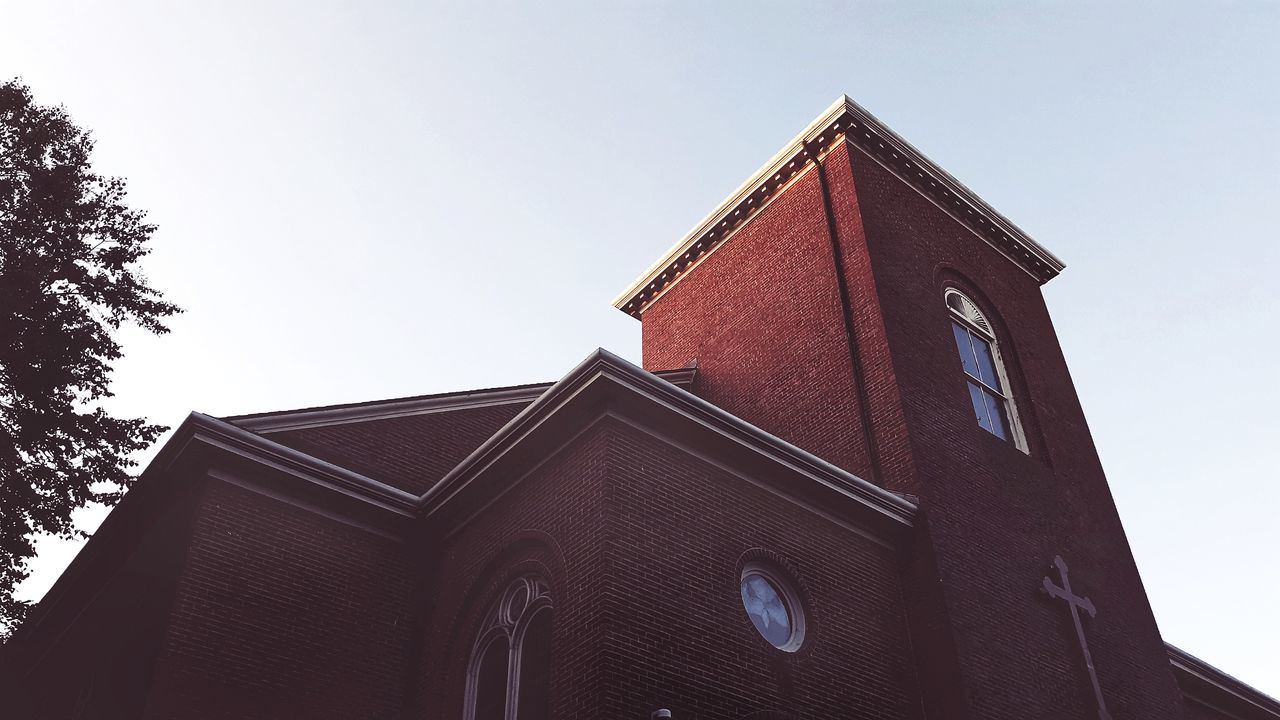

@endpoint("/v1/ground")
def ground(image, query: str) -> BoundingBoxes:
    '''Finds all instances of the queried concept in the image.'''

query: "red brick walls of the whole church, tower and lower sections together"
[10,117,1239,720]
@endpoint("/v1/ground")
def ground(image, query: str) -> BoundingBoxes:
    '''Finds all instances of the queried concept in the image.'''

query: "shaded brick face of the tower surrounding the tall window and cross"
[851,142,1180,719]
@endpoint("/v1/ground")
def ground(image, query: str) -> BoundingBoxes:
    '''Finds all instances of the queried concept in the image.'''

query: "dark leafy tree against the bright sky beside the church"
[0,75,179,630]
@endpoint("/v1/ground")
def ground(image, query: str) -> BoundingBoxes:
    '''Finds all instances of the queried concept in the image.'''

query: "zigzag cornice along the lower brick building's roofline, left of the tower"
[8,350,890,657]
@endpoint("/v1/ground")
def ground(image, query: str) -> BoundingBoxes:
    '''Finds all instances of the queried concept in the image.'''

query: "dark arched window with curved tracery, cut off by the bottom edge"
[465,575,552,720]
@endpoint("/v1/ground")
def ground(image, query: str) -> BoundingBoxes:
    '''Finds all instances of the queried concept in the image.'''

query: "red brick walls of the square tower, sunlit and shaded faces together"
[644,146,1180,720]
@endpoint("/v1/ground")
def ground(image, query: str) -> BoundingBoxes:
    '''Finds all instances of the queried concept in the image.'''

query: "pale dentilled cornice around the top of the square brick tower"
[613,95,1065,318]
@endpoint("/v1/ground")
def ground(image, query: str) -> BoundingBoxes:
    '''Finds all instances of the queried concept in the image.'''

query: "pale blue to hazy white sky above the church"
[0,0,1280,696]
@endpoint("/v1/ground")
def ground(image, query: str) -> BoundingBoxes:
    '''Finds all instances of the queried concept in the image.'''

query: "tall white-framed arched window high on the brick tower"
[946,288,1027,452]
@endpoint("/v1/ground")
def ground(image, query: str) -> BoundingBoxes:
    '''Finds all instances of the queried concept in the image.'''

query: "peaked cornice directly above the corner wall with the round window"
[417,350,916,538]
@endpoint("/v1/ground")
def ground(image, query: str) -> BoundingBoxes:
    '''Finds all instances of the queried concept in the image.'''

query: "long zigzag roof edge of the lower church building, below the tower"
[14,350,916,653]
